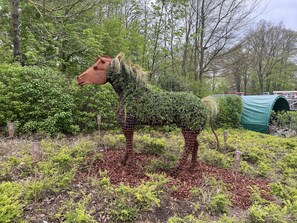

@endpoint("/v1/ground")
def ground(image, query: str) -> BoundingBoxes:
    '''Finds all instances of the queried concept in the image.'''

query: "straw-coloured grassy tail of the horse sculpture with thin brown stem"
[201,96,220,150]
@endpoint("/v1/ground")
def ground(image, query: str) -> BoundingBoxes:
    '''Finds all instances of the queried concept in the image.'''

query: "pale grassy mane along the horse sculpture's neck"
[110,53,147,82]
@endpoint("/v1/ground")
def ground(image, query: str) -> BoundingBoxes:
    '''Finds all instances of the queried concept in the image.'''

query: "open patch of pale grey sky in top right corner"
[259,0,297,31]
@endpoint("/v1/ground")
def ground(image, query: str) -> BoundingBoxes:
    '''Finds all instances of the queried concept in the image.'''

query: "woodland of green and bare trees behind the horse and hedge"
[0,0,297,97]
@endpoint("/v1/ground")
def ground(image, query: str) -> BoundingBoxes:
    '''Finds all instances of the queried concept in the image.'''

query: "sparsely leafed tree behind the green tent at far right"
[247,20,297,94]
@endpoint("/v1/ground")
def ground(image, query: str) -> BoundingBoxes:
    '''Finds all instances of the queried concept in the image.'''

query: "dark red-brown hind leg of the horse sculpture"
[172,130,198,176]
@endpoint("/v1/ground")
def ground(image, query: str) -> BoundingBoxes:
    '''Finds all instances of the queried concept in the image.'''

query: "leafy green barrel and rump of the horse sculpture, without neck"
[124,90,207,131]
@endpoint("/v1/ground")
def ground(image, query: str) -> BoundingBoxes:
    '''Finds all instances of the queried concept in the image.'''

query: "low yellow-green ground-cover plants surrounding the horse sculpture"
[0,129,297,223]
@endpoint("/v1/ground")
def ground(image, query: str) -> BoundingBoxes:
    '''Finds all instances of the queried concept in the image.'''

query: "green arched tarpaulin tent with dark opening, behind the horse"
[241,95,290,133]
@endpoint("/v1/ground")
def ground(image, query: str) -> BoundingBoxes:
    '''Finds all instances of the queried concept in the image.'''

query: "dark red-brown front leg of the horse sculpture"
[122,125,134,166]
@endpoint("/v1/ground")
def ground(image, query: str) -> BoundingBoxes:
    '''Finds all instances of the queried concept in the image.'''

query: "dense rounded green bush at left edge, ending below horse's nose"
[0,65,78,133]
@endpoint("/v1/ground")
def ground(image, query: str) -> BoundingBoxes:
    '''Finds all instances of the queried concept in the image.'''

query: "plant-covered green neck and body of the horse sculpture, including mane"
[107,55,207,132]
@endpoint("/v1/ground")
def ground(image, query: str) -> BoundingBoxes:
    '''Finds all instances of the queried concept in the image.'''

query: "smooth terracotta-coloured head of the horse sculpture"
[77,56,112,86]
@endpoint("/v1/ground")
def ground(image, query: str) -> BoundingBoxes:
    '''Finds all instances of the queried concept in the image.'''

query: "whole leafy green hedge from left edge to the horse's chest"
[0,64,116,134]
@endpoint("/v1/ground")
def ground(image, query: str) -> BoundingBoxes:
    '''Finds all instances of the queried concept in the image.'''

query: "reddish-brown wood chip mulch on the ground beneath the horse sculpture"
[75,150,272,209]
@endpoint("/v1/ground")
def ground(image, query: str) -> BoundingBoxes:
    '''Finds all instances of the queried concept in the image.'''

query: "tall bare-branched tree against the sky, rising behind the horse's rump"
[183,0,260,87]
